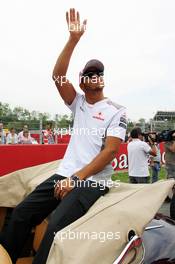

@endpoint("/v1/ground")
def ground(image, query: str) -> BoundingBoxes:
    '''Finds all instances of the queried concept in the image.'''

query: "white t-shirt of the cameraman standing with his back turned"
[128,138,151,177]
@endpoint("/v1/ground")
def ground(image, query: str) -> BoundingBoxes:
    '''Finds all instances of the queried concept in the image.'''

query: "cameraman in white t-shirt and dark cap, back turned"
[128,127,157,183]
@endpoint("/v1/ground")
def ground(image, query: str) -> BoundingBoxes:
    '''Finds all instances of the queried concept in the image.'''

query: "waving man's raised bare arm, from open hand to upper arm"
[52,8,86,105]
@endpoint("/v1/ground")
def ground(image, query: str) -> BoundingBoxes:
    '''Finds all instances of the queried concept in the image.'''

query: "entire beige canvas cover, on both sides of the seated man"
[0,161,174,264]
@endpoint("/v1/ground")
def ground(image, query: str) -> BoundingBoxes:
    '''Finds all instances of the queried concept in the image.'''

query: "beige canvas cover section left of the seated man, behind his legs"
[0,160,61,207]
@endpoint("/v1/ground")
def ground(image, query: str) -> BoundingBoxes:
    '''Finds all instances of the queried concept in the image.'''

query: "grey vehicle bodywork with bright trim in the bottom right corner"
[113,214,175,264]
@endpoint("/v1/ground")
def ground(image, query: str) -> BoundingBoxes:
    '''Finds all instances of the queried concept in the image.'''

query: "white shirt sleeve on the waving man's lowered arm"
[106,108,127,140]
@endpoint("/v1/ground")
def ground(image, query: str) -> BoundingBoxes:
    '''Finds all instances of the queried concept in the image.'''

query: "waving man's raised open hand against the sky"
[66,8,87,41]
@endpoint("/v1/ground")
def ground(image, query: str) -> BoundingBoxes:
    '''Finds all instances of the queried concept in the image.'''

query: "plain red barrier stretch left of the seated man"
[0,144,67,176]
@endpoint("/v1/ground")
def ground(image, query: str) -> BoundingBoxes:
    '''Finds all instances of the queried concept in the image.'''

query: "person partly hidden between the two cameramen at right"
[150,142,161,183]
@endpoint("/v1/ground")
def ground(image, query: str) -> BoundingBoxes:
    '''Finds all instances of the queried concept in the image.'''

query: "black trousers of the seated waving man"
[0,174,109,264]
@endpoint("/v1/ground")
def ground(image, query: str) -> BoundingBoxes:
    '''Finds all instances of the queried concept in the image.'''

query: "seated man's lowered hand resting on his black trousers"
[54,177,74,199]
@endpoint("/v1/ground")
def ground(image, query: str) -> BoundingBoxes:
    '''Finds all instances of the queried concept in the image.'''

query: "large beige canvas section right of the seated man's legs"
[47,180,174,264]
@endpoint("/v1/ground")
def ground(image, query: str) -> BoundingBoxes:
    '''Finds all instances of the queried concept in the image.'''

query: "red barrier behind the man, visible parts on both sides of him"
[0,143,165,176]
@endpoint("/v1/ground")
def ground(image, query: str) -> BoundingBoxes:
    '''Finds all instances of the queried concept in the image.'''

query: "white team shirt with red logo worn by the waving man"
[57,93,126,184]
